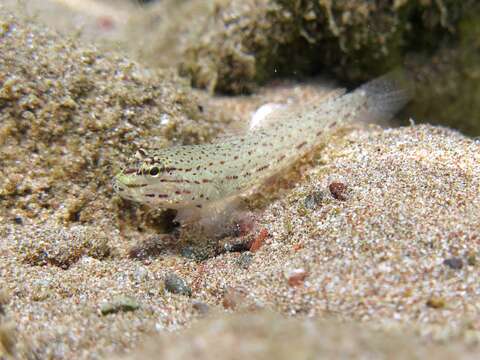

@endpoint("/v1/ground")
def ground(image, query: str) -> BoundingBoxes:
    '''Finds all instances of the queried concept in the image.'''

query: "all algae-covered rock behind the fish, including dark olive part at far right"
[127,0,480,135]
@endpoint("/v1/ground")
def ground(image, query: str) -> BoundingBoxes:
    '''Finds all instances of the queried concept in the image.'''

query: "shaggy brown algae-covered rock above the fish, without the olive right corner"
[127,0,473,93]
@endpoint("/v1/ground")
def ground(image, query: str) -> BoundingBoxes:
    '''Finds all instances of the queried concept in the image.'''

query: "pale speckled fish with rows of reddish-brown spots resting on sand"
[115,73,409,209]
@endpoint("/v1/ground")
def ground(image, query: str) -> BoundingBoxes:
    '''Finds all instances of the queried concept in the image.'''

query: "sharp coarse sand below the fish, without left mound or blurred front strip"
[1,126,480,358]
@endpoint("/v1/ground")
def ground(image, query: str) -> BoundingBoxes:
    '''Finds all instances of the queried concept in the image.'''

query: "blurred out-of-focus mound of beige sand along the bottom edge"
[111,313,475,360]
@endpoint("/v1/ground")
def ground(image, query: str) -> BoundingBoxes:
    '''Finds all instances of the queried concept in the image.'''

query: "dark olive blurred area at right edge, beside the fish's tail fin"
[408,10,480,136]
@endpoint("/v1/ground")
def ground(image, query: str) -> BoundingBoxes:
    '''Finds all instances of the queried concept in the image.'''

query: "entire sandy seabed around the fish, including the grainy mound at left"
[0,2,480,359]
